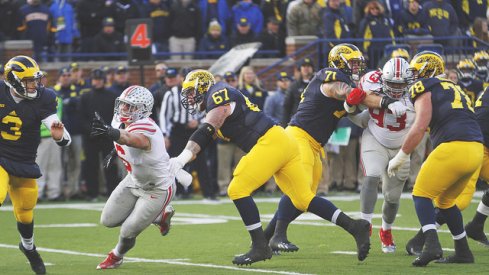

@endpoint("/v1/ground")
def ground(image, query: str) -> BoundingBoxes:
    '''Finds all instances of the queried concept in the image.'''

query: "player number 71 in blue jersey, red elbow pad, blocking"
[265,44,406,252]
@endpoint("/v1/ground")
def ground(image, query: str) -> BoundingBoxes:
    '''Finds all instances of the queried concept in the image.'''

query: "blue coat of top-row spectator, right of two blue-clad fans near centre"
[232,0,264,34]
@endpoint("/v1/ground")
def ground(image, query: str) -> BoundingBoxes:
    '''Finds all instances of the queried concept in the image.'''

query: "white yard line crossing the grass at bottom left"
[0,244,309,275]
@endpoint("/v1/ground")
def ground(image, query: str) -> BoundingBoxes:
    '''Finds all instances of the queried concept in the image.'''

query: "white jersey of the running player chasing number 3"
[112,118,175,189]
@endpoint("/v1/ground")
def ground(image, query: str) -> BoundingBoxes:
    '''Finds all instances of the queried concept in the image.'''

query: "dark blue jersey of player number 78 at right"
[409,78,483,148]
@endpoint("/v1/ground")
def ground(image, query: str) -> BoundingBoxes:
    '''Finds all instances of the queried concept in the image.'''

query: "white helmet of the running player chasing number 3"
[114,85,154,123]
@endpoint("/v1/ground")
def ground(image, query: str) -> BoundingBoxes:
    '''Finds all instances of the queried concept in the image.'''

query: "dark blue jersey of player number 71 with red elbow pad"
[290,68,355,146]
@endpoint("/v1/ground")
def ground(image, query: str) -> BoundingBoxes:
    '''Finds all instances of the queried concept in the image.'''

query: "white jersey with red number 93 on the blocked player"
[360,71,416,149]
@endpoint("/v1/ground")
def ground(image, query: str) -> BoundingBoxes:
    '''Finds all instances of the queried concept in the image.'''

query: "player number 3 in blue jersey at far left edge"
[0,56,71,274]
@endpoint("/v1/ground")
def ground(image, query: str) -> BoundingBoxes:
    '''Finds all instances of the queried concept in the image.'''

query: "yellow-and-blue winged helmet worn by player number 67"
[182,70,216,114]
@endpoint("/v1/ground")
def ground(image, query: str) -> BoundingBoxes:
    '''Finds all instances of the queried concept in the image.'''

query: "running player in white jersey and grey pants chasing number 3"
[90,86,192,269]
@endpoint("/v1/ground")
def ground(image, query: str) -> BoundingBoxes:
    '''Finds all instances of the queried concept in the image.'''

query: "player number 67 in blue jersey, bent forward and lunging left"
[170,70,370,265]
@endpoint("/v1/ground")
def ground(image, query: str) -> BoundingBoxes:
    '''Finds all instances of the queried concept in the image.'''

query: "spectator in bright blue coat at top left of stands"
[49,0,80,61]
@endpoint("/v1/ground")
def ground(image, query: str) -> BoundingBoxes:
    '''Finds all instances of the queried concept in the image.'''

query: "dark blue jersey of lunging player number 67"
[205,82,276,153]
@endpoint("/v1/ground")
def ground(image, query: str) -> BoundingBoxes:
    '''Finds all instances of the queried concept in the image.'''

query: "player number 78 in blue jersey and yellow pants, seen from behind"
[388,51,484,266]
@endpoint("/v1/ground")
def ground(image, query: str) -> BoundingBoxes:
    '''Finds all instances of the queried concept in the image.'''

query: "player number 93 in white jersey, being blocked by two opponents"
[351,58,415,253]
